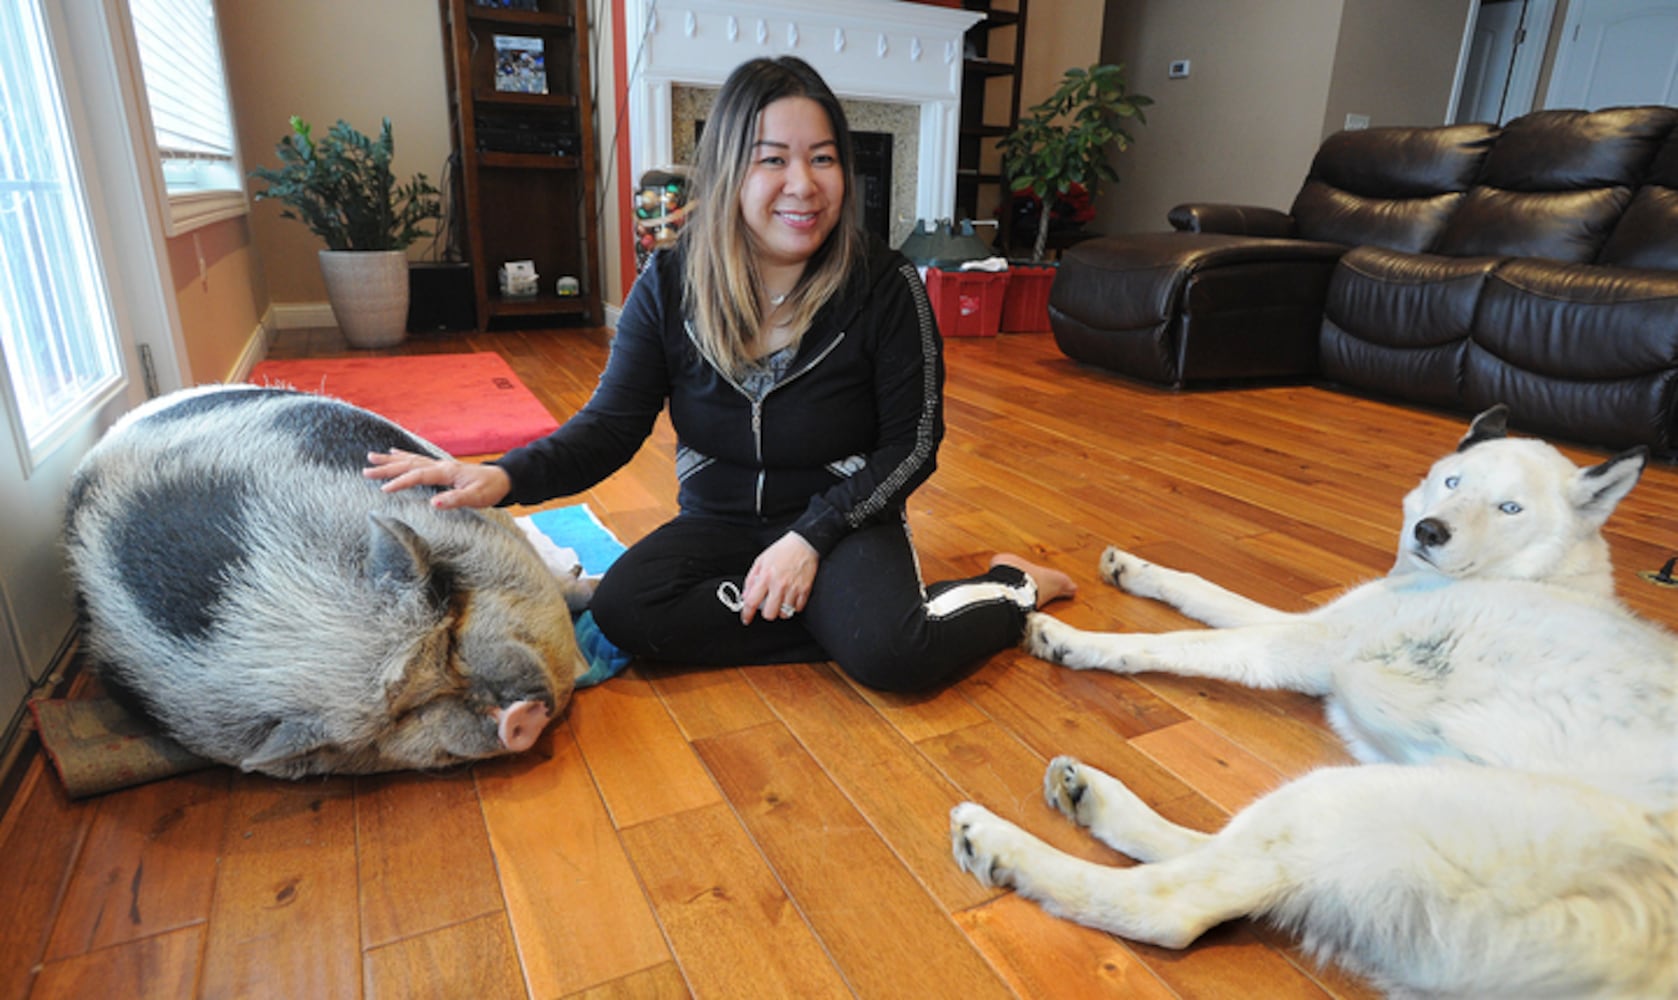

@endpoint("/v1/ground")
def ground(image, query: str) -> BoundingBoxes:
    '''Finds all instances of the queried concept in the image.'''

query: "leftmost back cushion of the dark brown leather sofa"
[1290,124,1498,252]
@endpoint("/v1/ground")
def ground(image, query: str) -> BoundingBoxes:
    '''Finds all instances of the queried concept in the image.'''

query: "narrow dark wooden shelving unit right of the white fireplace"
[955,0,1027,247]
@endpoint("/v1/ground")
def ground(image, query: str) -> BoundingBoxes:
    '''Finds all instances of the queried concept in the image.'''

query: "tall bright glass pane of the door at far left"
[0,0,122,466]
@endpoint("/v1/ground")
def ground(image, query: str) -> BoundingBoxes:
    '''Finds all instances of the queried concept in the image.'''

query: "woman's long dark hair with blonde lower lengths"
[681,55,864,376]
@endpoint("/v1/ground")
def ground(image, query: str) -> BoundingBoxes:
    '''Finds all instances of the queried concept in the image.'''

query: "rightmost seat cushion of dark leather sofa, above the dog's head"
[1463,260,1678,450]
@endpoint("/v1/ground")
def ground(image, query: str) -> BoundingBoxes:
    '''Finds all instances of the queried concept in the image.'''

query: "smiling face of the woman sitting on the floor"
[740,97,844,267]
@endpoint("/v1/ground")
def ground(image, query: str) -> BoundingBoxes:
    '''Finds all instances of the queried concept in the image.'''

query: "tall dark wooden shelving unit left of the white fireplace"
[441,0,602,329]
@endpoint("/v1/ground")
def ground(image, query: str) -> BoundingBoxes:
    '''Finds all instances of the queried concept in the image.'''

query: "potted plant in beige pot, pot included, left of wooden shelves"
[250,116,443,347]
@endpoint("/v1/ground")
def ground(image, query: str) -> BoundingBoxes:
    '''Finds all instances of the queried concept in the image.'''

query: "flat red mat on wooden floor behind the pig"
[250,351,559,455]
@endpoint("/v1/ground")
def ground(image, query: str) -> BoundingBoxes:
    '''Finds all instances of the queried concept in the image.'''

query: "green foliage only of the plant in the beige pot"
[250,116,443,250]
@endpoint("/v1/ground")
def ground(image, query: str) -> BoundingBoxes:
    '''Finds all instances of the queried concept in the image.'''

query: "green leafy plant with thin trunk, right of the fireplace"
[997,64,1153,260]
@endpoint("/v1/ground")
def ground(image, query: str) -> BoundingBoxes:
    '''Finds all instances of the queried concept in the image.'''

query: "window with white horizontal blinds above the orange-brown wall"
[129,0,245,237]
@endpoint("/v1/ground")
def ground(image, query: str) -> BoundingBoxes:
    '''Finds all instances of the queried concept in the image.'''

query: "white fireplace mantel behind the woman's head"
[624,0,983,220]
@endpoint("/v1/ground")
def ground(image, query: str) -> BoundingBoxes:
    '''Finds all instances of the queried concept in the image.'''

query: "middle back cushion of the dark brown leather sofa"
[1435,107,1678,263]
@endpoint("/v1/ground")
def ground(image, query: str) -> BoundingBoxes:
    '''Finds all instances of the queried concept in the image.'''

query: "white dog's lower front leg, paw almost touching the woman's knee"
[1022,612,1332,696]
